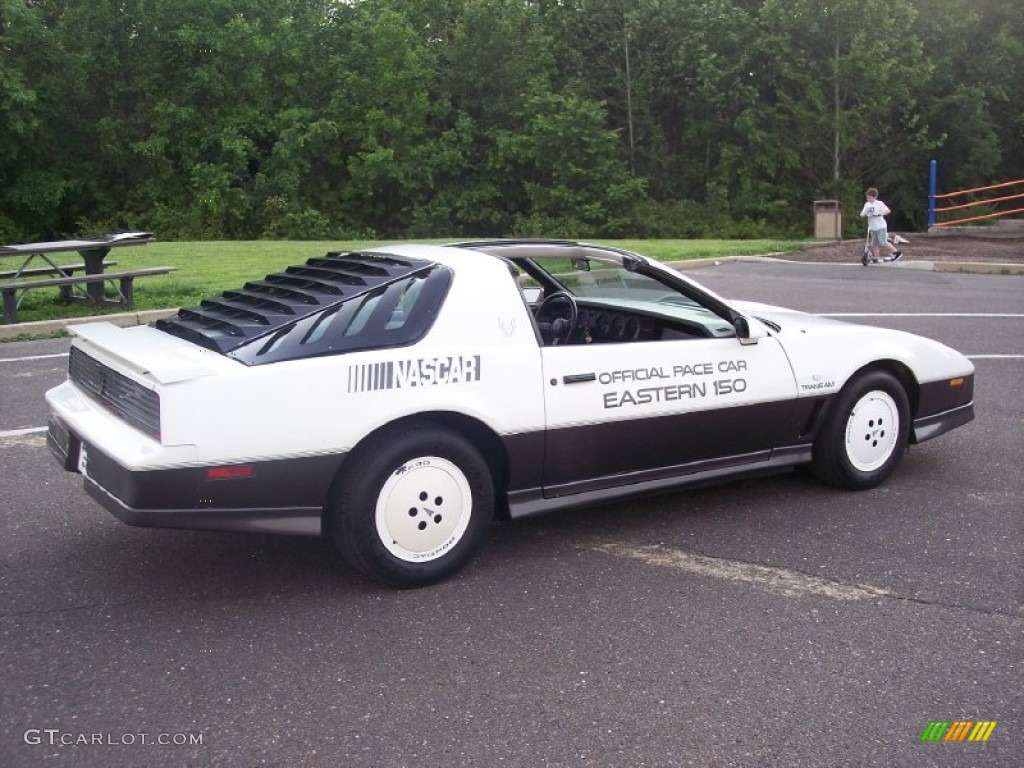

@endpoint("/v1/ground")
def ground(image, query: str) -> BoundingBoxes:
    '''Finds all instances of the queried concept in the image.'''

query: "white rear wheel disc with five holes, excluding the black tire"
[376,456,473,562]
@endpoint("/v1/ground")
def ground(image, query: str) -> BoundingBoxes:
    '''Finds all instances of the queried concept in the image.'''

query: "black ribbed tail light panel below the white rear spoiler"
[68,346,160,441]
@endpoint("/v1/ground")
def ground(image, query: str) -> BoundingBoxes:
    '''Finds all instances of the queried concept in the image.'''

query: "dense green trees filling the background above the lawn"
[0,0,1024,242]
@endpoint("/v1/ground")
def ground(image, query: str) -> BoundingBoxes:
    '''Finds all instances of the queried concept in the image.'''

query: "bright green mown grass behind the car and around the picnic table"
[4,239,801,323]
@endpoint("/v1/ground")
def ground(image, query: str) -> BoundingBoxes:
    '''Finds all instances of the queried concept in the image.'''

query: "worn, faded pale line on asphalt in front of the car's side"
[590,542,893,600]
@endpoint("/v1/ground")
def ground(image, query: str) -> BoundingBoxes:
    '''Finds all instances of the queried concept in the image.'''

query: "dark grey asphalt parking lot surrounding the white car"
[0,262,1024,768]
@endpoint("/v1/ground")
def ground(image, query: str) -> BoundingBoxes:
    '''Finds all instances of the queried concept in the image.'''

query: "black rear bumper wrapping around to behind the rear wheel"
[46,416,343,536]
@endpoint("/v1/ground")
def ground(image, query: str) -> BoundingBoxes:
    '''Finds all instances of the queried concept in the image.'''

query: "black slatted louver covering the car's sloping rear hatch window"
[154,252,429,354]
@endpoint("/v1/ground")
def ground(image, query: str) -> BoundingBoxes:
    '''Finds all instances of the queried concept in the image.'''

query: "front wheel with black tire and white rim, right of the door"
[811,371,910,490]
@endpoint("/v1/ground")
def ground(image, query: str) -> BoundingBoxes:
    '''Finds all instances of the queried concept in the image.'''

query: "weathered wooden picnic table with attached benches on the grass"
[0,232,174,324]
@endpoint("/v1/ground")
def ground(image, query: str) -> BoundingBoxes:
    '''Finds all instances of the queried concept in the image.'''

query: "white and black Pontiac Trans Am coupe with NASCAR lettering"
[46,241,974,587]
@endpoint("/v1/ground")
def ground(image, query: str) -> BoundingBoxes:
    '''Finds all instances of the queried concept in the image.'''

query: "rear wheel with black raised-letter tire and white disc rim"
[328,425,495,589]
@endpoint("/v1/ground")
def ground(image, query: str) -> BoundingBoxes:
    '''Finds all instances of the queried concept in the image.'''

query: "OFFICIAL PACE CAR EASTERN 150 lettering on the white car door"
[597,360,746,409]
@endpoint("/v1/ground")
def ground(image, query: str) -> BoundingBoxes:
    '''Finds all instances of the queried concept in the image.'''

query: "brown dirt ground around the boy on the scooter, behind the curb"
[780,232,1024,264]
